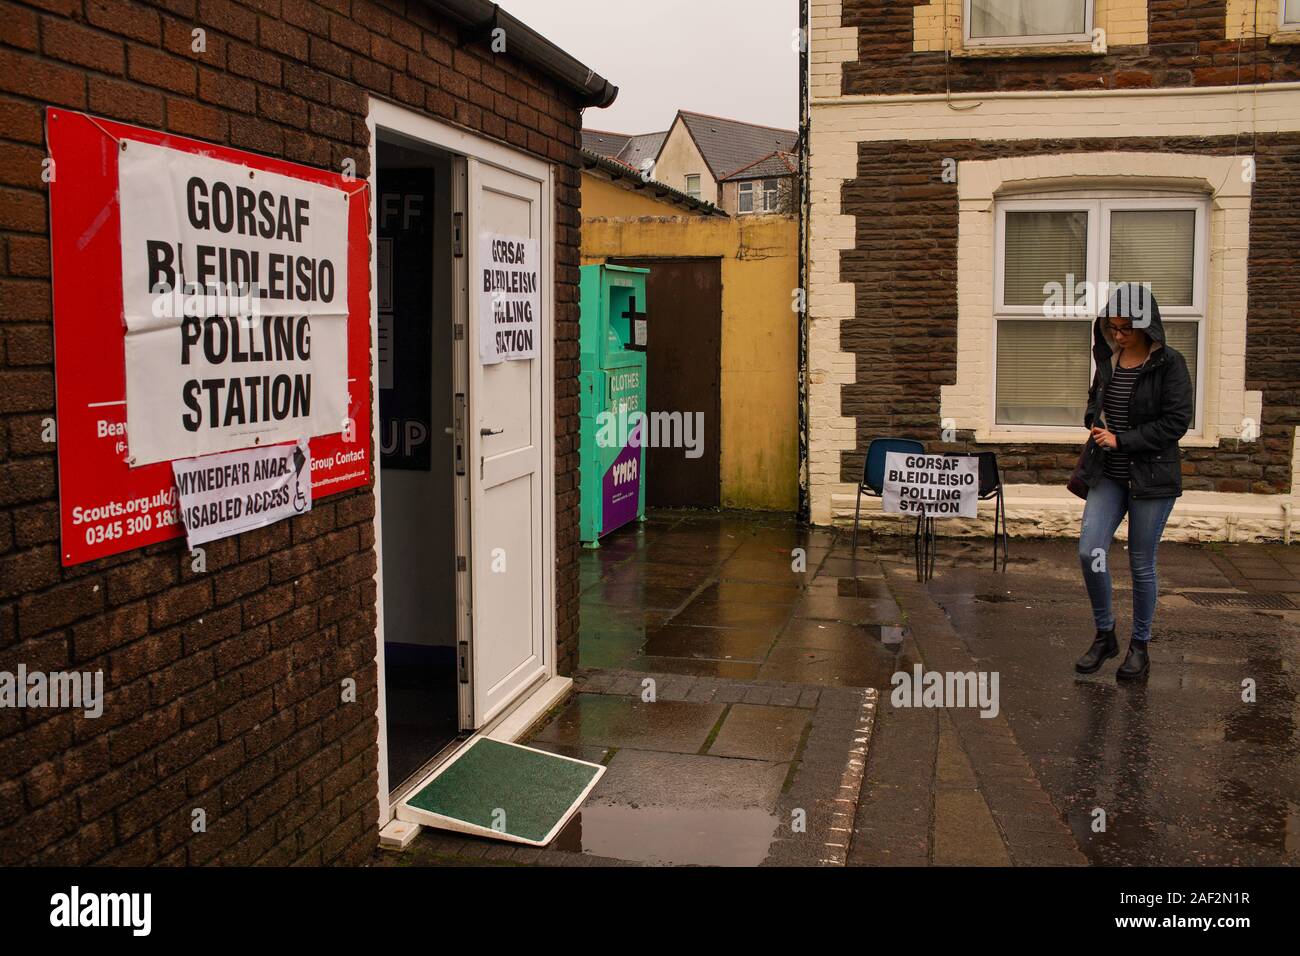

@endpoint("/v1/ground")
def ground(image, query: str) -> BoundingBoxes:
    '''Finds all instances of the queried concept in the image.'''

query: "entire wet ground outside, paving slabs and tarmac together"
[377,512,1300,865]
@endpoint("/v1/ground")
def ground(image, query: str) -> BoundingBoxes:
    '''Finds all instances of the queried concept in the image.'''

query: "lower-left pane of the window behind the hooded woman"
[997,319,1092,427]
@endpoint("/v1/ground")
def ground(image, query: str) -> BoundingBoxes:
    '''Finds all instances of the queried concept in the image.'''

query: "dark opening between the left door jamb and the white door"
[376,131,465,791]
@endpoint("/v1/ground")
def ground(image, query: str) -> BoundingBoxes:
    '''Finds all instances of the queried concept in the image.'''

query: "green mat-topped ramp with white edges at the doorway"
[398,737,605,847]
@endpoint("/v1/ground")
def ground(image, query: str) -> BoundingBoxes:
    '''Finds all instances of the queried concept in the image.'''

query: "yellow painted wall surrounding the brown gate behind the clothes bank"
[582,174,800,511]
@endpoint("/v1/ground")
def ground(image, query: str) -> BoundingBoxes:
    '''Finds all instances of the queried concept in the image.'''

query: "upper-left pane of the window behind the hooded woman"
[1004,212,1088,306]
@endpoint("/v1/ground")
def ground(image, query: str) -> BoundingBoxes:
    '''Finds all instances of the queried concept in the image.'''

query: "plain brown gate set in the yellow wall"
[610,259,723,507]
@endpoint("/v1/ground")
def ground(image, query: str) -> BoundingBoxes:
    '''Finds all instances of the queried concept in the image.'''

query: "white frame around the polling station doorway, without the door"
[365,96,556,827]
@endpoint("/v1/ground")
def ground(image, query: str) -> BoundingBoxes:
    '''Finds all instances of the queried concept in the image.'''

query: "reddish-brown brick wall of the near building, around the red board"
[0,0,580,865]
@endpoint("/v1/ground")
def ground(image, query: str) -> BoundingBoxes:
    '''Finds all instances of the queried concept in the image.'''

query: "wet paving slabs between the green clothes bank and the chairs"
[579,511,901,687]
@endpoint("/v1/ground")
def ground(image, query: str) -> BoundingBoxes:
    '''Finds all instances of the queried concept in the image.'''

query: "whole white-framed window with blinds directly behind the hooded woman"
[993,194,1209,434]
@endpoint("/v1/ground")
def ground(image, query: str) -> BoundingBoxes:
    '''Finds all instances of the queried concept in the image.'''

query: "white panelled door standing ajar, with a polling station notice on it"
[465,159,554,727]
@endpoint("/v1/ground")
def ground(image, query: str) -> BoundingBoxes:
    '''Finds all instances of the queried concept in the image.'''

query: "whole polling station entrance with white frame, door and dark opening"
[368,99,571,825]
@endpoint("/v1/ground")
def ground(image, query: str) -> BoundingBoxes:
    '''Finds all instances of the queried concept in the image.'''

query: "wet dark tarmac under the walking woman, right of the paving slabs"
[909,541,1300,865]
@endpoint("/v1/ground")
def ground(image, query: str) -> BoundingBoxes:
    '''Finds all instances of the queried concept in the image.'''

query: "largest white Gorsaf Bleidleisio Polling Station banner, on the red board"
[117,142,348,466]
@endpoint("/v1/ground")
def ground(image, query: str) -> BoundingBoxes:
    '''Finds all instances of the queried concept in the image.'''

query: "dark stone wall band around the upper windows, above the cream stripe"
[842,0,1300,95]
